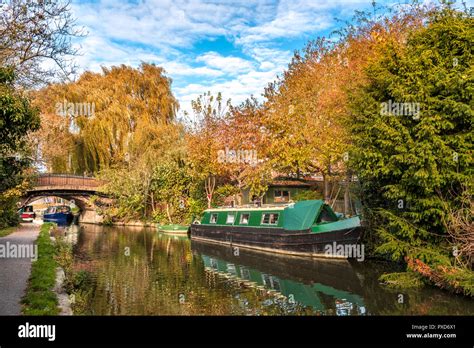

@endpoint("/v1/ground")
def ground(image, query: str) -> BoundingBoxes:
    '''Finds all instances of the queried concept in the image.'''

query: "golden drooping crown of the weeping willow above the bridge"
[32,63,178,174]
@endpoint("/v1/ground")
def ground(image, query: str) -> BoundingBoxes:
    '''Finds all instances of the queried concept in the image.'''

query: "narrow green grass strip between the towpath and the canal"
[22,223,59,315]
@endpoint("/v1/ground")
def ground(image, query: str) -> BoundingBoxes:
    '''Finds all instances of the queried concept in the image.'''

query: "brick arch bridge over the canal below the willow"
[21,174,110,223]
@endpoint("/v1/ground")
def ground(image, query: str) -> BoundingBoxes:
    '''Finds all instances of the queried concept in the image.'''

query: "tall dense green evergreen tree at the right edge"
[352,5,474,265]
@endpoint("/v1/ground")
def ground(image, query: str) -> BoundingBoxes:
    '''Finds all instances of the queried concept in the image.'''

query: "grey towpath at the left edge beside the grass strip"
[0,223,40,315]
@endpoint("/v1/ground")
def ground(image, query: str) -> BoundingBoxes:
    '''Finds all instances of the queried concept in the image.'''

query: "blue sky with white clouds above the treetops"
[72,0,470,117]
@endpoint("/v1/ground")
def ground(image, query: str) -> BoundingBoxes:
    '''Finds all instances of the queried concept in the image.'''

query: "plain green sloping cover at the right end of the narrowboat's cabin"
[283,200,324,231]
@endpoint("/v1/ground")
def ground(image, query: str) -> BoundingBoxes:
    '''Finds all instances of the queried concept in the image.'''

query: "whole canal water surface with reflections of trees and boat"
[65,225,474,316]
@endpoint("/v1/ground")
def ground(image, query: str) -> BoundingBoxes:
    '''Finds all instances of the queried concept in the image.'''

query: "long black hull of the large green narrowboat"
[190,224,362,258]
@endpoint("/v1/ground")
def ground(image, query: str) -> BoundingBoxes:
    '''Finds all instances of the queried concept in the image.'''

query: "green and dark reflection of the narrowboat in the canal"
[191,240,366,316]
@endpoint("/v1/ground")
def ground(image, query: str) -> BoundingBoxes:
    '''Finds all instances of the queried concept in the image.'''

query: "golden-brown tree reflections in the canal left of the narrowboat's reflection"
[76,226,318,315]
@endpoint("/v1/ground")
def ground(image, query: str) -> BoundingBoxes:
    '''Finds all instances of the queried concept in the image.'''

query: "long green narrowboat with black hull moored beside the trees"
[190,200,363,258]
